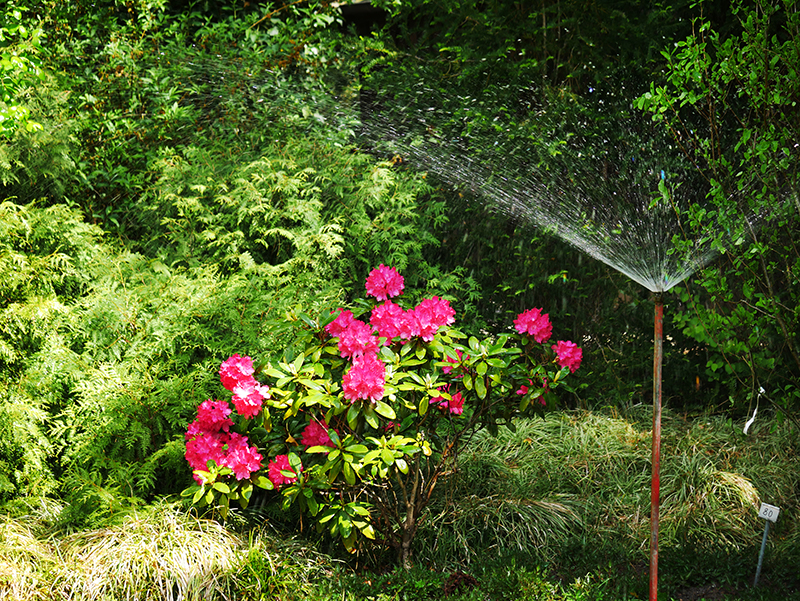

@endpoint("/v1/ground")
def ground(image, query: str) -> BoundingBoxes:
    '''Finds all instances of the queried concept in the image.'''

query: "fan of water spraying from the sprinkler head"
[362,81,762,293]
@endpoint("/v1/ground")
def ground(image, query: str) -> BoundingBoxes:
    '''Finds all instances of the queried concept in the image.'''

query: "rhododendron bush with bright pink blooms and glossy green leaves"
[185,265,581,563]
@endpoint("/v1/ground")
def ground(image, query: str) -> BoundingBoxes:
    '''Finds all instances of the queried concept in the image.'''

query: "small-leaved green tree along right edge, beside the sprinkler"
[637,2,800,415]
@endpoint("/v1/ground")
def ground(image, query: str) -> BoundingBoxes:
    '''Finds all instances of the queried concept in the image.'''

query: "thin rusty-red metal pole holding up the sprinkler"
[650,293,664,601]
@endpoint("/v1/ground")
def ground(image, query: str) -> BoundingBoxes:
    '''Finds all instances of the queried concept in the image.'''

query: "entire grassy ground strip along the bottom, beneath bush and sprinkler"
[0,408,800,601]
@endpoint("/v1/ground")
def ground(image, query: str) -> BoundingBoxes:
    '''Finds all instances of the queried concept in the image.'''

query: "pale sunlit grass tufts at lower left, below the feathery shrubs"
[0,502,333,601]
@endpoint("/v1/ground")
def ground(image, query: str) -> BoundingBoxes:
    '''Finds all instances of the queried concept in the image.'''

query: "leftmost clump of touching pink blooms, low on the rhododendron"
[185,399,263,484]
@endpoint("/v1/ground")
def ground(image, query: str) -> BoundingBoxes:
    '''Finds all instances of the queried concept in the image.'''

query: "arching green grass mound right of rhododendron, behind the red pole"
[421,411,780,561]
